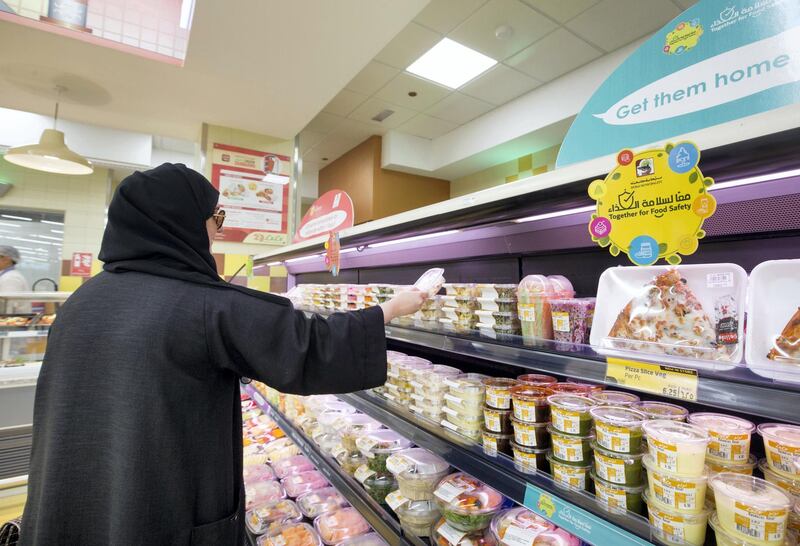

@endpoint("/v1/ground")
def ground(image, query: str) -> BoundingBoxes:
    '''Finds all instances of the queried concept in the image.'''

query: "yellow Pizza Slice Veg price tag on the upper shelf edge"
[606,357,698,402]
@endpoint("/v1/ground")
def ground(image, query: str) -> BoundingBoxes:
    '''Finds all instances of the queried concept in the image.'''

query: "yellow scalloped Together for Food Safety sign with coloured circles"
[589,142,717,265]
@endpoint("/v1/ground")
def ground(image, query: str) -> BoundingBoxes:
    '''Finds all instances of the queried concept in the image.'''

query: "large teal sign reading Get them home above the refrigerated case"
[556,0,800,167]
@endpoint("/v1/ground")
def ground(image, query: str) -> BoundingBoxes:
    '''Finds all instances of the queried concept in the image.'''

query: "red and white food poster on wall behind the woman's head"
[211,143,292,245]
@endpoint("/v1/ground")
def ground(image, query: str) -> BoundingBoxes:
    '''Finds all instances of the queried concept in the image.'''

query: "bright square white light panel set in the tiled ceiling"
[406,38,497,89]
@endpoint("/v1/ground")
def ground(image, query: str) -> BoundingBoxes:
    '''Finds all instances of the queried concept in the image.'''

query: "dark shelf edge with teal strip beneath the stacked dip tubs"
[338,391,651,546]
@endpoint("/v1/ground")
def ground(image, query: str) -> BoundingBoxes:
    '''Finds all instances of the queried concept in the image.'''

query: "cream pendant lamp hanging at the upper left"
[5,89,94,175]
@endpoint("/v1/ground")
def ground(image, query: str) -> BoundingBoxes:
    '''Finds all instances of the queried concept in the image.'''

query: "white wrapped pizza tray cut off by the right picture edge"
[745,260,800,382]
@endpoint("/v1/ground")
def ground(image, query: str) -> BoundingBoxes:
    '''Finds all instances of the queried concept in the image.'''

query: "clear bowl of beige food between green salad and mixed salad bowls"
[386,448,450,501]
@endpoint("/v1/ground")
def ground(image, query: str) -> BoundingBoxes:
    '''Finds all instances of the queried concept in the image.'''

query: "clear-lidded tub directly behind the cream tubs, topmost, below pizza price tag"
[689,413,756,463]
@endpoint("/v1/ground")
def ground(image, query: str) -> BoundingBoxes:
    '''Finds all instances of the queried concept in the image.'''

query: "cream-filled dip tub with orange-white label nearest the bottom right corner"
[710,472,792,545]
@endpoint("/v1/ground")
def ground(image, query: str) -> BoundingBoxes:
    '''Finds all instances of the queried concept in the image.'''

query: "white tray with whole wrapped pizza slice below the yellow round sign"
[591,264,747,369]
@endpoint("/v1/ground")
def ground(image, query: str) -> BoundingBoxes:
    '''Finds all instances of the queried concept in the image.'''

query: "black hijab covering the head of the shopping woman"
[99,163,284,303]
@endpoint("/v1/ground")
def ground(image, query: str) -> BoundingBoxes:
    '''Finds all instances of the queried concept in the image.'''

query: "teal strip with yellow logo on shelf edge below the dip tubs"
[523,483,651,546]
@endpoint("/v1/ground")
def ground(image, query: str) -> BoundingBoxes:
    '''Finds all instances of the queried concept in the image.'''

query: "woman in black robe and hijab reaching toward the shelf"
[20,164,427,546]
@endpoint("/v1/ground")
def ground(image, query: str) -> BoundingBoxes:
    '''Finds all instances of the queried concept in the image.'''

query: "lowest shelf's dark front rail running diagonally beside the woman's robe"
[243,384,425,546]
